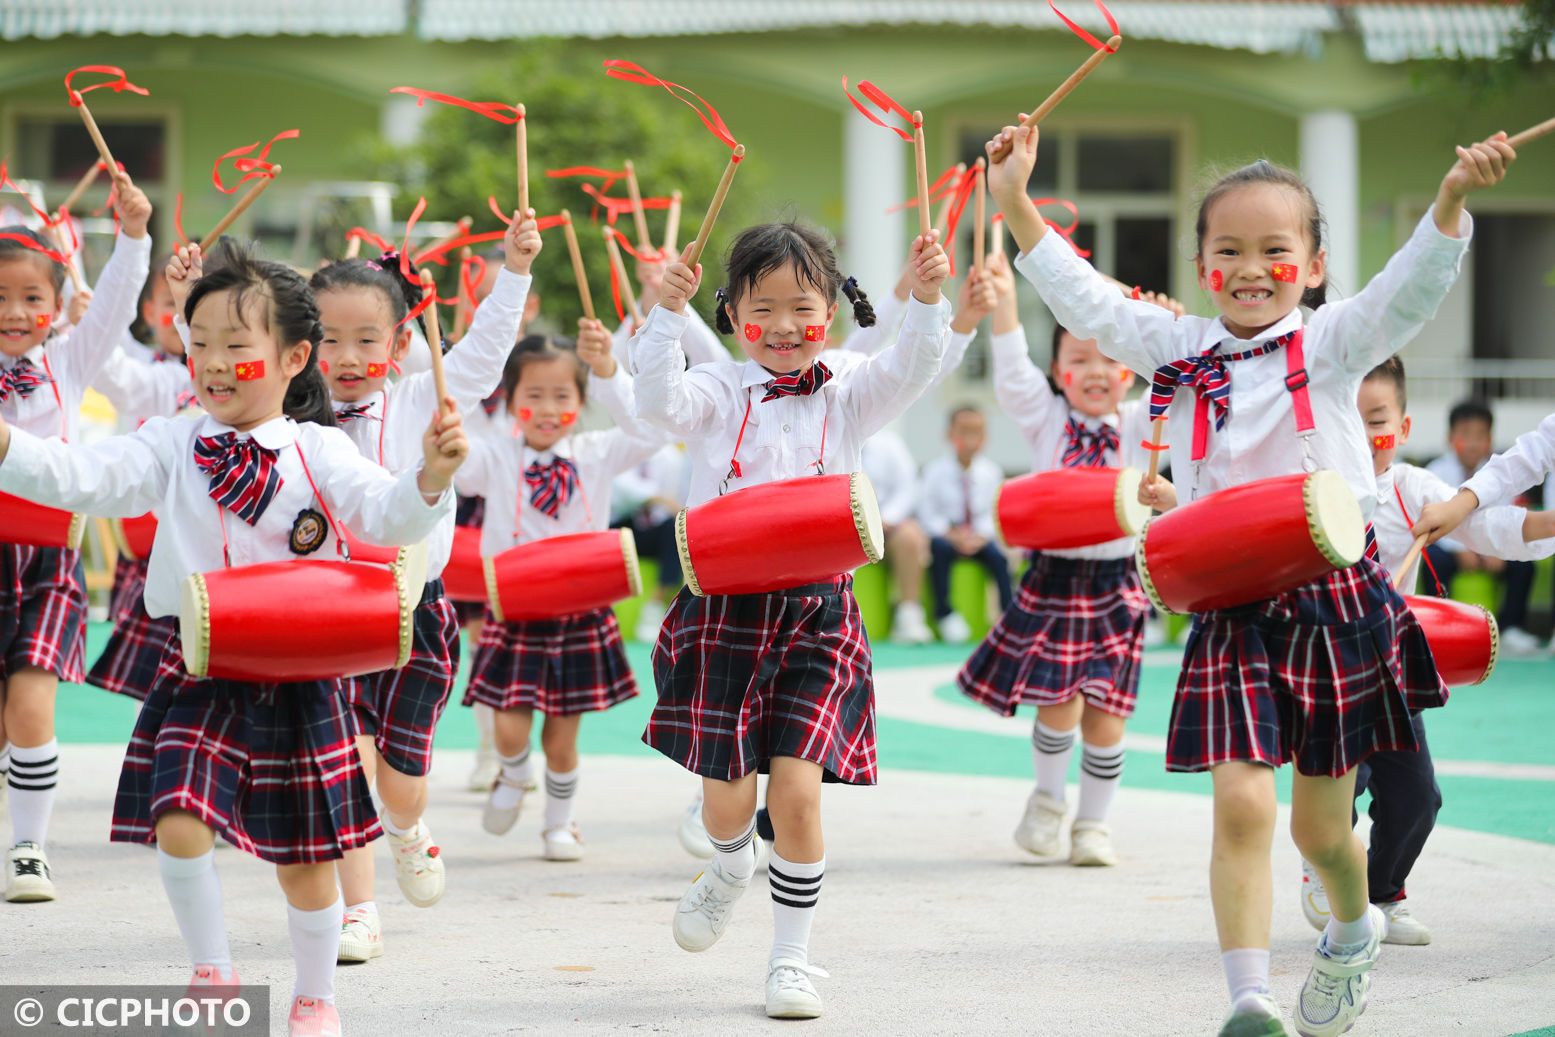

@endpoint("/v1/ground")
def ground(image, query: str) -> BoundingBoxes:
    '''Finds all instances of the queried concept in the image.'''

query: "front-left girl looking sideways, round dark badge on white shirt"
[0,239,470,1037]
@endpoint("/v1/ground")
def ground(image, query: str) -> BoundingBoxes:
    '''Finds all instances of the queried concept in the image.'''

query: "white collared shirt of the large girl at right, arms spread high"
[1015,211,1473,516]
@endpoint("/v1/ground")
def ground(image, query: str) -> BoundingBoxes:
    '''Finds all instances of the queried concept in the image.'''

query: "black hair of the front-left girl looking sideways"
[183,238,336,424]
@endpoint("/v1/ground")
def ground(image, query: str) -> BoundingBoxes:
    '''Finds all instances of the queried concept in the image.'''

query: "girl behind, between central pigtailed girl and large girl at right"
[956,255,1149,866]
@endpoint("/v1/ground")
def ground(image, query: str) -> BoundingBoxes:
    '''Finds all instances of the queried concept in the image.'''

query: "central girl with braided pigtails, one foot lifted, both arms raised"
[636,224,950,1018]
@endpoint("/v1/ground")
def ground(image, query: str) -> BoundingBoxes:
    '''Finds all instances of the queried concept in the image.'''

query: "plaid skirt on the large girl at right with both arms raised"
[1166,558,1448,777]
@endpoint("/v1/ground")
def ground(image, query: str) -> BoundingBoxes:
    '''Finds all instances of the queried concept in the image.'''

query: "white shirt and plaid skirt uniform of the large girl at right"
[1015,206,1473,776]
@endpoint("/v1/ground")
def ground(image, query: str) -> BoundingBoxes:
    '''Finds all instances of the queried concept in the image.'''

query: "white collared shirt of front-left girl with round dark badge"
[0,415,454,617]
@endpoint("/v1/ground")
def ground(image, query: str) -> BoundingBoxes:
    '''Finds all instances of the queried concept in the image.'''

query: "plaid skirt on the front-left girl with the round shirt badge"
[110,637,383,864]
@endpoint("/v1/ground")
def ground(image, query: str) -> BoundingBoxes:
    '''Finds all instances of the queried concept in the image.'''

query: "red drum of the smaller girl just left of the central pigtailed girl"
[471,529,642,623]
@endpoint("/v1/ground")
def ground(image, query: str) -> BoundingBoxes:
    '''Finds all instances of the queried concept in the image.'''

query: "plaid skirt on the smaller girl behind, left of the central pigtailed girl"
[465,608,638,717]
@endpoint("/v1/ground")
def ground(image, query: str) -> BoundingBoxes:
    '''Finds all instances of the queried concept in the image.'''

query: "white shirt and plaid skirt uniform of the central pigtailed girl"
[636,300,950,785]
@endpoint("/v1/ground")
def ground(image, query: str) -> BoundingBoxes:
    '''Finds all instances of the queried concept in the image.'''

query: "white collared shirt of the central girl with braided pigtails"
[636,299,950,505]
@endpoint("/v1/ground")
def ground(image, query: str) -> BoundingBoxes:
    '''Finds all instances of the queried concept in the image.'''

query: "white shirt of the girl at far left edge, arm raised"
[0,233,151,442]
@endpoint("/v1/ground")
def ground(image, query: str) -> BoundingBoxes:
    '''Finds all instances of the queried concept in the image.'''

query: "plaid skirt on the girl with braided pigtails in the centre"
[642,575,877,785]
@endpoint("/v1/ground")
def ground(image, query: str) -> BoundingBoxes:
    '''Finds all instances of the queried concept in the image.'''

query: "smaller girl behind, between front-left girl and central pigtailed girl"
[459,331,664,861]
